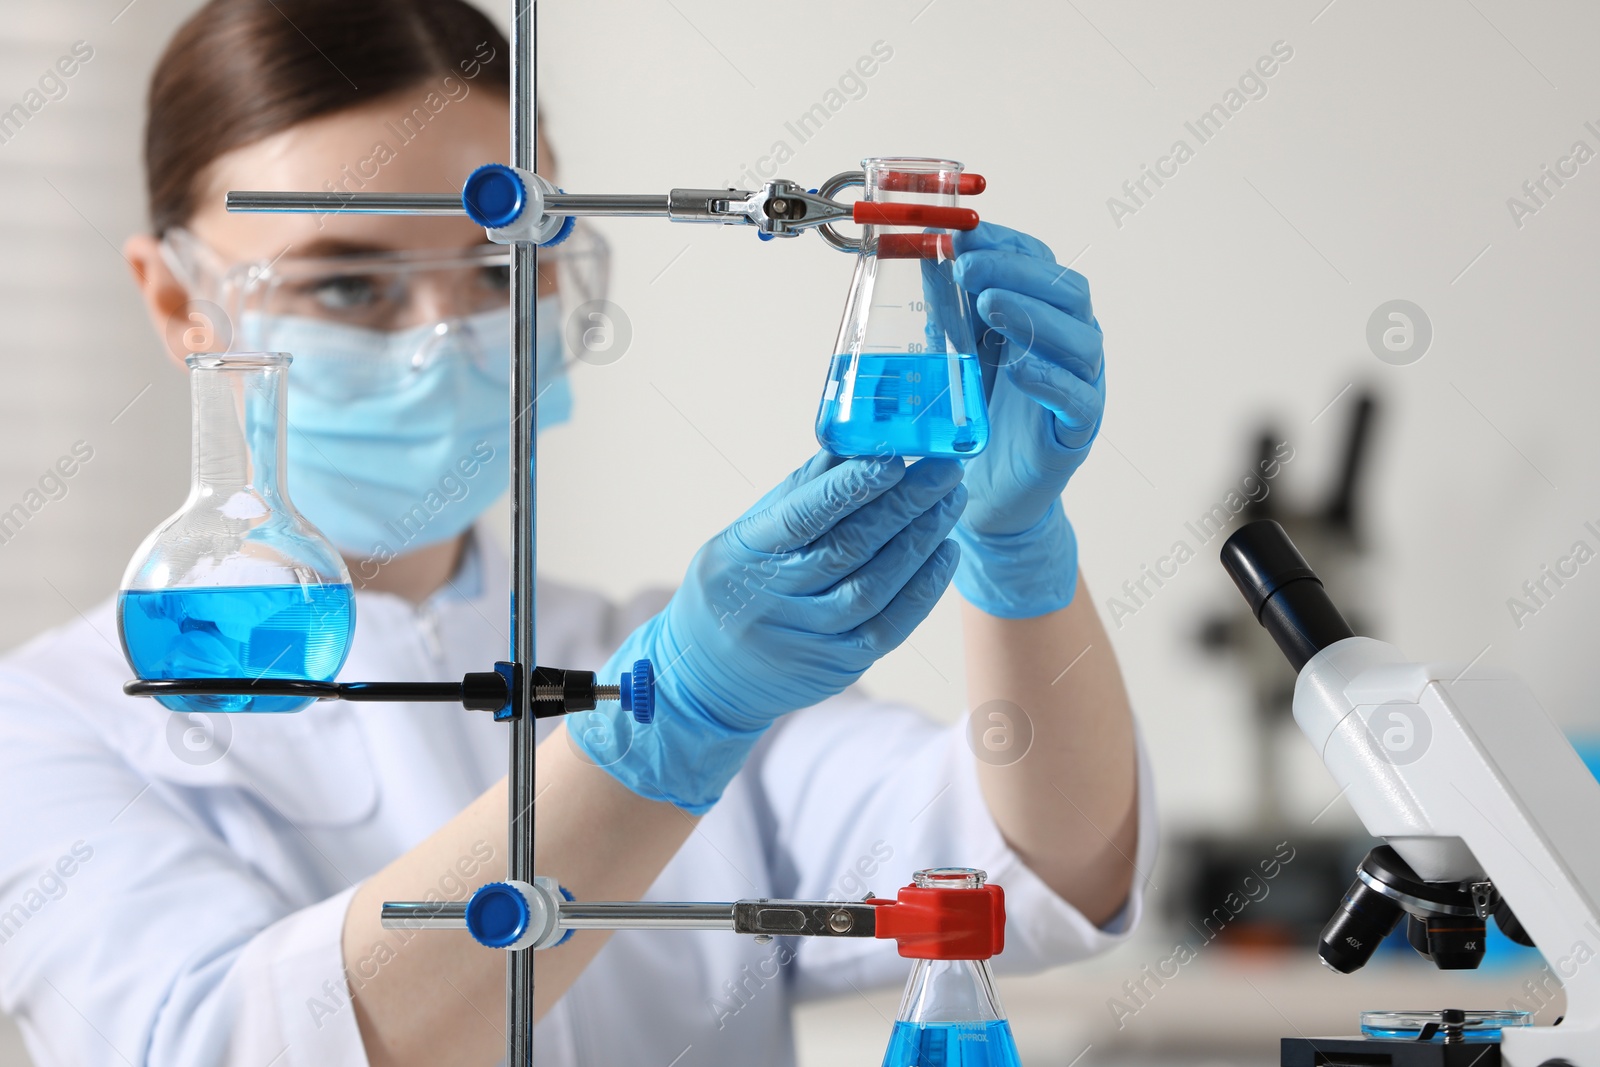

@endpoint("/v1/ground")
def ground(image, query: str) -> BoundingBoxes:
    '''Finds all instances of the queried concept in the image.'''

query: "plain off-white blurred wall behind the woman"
[0,0,1600,1062]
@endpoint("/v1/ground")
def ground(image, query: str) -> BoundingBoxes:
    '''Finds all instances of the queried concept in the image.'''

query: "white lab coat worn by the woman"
[0,536,1157,1067]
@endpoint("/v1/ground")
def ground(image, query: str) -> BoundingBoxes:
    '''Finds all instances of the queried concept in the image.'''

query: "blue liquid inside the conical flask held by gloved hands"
[816,352,989,459]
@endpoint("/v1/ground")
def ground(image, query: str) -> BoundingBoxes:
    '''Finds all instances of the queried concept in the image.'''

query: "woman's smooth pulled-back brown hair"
[144,0,510,237]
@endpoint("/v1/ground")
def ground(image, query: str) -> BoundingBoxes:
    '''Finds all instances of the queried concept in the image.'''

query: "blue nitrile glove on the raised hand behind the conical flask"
[952,222,1106,619]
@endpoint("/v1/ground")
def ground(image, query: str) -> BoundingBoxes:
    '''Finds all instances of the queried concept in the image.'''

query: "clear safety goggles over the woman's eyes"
[162,226,611,333]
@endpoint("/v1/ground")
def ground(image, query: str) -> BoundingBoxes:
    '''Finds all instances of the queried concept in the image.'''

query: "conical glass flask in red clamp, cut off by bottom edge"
[883,867,1021,1067]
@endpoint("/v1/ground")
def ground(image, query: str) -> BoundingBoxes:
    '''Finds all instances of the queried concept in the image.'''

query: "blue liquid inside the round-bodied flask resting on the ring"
[117,584,355,712]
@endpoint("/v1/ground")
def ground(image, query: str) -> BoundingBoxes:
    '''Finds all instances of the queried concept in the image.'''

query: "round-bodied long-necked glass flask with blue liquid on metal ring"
[117,352,355,712]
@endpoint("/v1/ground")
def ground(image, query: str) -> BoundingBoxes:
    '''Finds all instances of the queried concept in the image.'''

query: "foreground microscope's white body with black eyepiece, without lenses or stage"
[1224,522,1600,1067]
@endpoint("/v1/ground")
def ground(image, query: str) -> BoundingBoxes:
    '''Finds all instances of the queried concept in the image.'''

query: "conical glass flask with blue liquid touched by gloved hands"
[816,158,989,458]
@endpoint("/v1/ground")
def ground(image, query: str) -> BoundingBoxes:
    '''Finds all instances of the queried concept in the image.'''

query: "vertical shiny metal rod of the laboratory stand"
[506,0,539,1067]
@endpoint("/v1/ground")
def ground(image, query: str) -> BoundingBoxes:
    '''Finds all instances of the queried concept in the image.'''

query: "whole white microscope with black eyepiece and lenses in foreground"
[1222,520,1600,1067]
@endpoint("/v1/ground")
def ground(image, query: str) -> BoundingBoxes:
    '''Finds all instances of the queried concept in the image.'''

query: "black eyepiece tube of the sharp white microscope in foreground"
[1222,518,1355,670]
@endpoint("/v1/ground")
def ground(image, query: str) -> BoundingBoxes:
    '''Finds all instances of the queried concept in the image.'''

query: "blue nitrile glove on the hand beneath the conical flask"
[566,453,966,814]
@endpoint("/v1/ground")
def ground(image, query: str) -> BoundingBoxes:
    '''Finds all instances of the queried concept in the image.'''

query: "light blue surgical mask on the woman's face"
[235,296,571,563]
